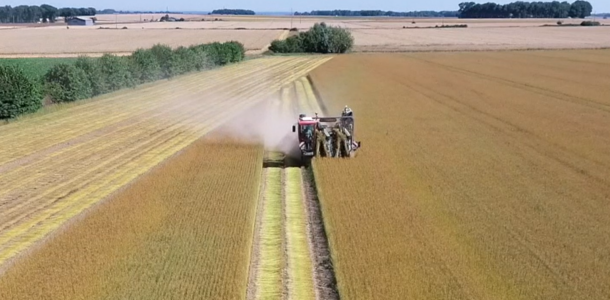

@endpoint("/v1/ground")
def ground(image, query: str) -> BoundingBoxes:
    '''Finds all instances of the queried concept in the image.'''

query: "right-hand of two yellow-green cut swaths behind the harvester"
[285,168,315,300]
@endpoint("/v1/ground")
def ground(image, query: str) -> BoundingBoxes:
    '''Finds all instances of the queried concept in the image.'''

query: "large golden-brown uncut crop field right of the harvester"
[311,50,610,299]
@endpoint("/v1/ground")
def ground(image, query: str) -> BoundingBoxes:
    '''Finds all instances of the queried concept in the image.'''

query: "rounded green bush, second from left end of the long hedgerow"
[44,63,93,103]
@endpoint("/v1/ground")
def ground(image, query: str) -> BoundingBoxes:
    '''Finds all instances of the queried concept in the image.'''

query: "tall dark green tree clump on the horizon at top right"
[458,0,593,18]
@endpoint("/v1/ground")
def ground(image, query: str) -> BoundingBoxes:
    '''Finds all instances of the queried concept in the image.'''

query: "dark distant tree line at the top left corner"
[0,4,96,23]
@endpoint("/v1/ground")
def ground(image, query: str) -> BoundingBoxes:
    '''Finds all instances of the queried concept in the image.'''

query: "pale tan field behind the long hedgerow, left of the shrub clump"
[0,28,283,57]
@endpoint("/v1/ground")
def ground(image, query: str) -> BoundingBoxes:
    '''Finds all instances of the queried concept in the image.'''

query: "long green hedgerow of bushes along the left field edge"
[0,42,245,119]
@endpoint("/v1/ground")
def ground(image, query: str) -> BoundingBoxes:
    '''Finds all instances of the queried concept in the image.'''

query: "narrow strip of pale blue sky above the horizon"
[1,0,610,13]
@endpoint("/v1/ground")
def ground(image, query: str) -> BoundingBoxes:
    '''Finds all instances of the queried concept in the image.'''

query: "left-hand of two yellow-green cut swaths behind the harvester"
[256,168,282,299]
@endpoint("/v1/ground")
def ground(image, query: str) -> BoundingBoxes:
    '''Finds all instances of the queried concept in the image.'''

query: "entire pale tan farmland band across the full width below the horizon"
[0,14,610,57]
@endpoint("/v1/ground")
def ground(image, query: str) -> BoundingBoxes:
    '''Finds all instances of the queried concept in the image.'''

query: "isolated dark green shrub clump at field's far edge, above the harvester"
[269,23,354,53]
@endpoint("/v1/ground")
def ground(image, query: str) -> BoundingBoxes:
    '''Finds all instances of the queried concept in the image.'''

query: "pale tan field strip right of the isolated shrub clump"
[352,25,610,52]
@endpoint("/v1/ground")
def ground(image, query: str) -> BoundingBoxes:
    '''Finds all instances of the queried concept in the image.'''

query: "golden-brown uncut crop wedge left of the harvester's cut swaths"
[0,139,262,299]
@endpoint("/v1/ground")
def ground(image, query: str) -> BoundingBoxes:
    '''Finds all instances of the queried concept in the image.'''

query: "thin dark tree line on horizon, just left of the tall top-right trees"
[294,10,458,18]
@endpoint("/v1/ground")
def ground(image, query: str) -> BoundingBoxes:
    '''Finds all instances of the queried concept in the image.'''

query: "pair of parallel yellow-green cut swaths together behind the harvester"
[249,168,316,299]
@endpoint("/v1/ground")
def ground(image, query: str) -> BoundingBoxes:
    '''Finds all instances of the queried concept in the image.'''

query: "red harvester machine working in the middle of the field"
[292,106,361,159]
